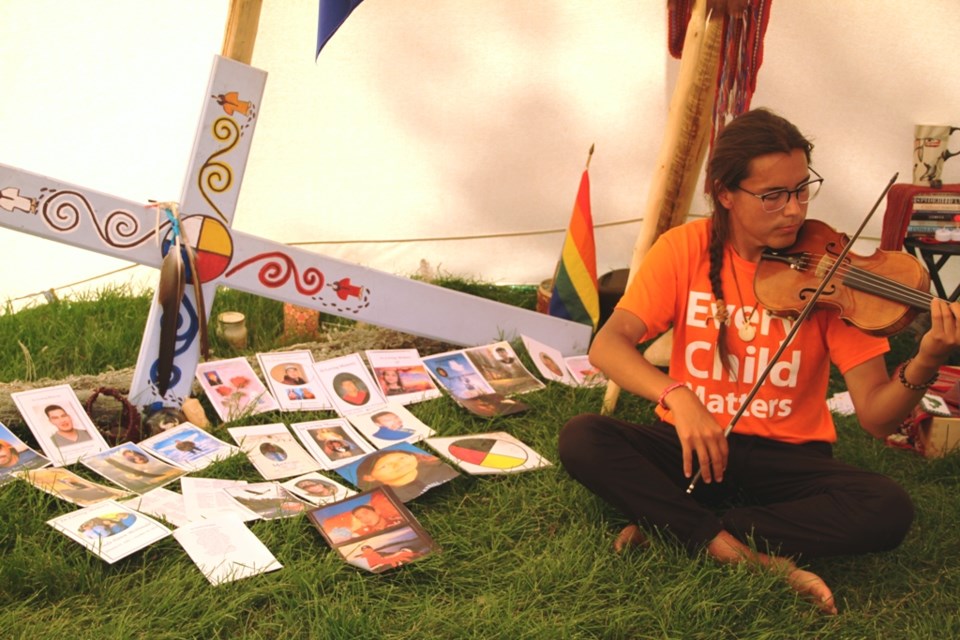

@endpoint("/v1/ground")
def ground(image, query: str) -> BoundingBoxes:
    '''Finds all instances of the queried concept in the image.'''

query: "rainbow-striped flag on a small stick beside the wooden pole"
[548,170,600,330]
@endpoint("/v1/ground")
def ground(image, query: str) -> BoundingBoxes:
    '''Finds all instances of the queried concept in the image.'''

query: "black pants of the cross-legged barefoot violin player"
[559,414,913,557]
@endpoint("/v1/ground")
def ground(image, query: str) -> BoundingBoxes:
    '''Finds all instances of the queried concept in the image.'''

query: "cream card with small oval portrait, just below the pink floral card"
[227,422,320,480]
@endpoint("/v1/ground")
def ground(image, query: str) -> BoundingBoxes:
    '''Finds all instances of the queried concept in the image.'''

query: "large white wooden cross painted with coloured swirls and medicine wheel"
[0,56,591,407]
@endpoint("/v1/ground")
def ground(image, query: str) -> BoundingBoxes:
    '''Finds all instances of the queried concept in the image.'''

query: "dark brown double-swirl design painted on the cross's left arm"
[43,190,160,249]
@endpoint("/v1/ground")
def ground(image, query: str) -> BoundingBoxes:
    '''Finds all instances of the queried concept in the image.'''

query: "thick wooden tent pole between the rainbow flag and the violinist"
[601,0,723,414]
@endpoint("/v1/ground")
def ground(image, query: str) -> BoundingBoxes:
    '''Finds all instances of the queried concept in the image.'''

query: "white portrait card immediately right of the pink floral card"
[257,349,333,411]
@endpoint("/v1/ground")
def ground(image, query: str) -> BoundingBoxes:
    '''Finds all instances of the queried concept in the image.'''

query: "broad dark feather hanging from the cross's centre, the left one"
[157,208,187,396]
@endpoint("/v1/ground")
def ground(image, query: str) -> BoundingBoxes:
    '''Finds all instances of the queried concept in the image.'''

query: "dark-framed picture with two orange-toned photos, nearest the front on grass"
[307,487,440,573]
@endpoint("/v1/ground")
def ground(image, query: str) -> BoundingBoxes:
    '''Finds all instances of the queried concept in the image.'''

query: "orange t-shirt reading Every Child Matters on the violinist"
[617,219,890,443]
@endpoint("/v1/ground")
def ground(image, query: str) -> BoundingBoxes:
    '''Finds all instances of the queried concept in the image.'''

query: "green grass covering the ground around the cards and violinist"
[0,283,960,640]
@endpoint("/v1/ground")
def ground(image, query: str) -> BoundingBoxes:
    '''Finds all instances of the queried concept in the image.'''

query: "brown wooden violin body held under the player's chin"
[753,220,934,336]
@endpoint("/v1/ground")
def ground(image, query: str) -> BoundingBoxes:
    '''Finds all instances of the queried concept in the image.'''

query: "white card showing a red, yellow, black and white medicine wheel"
[427,431,551,475]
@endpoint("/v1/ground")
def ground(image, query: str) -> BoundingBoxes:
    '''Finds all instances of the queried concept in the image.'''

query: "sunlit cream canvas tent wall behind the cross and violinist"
[0,0,960,306]
